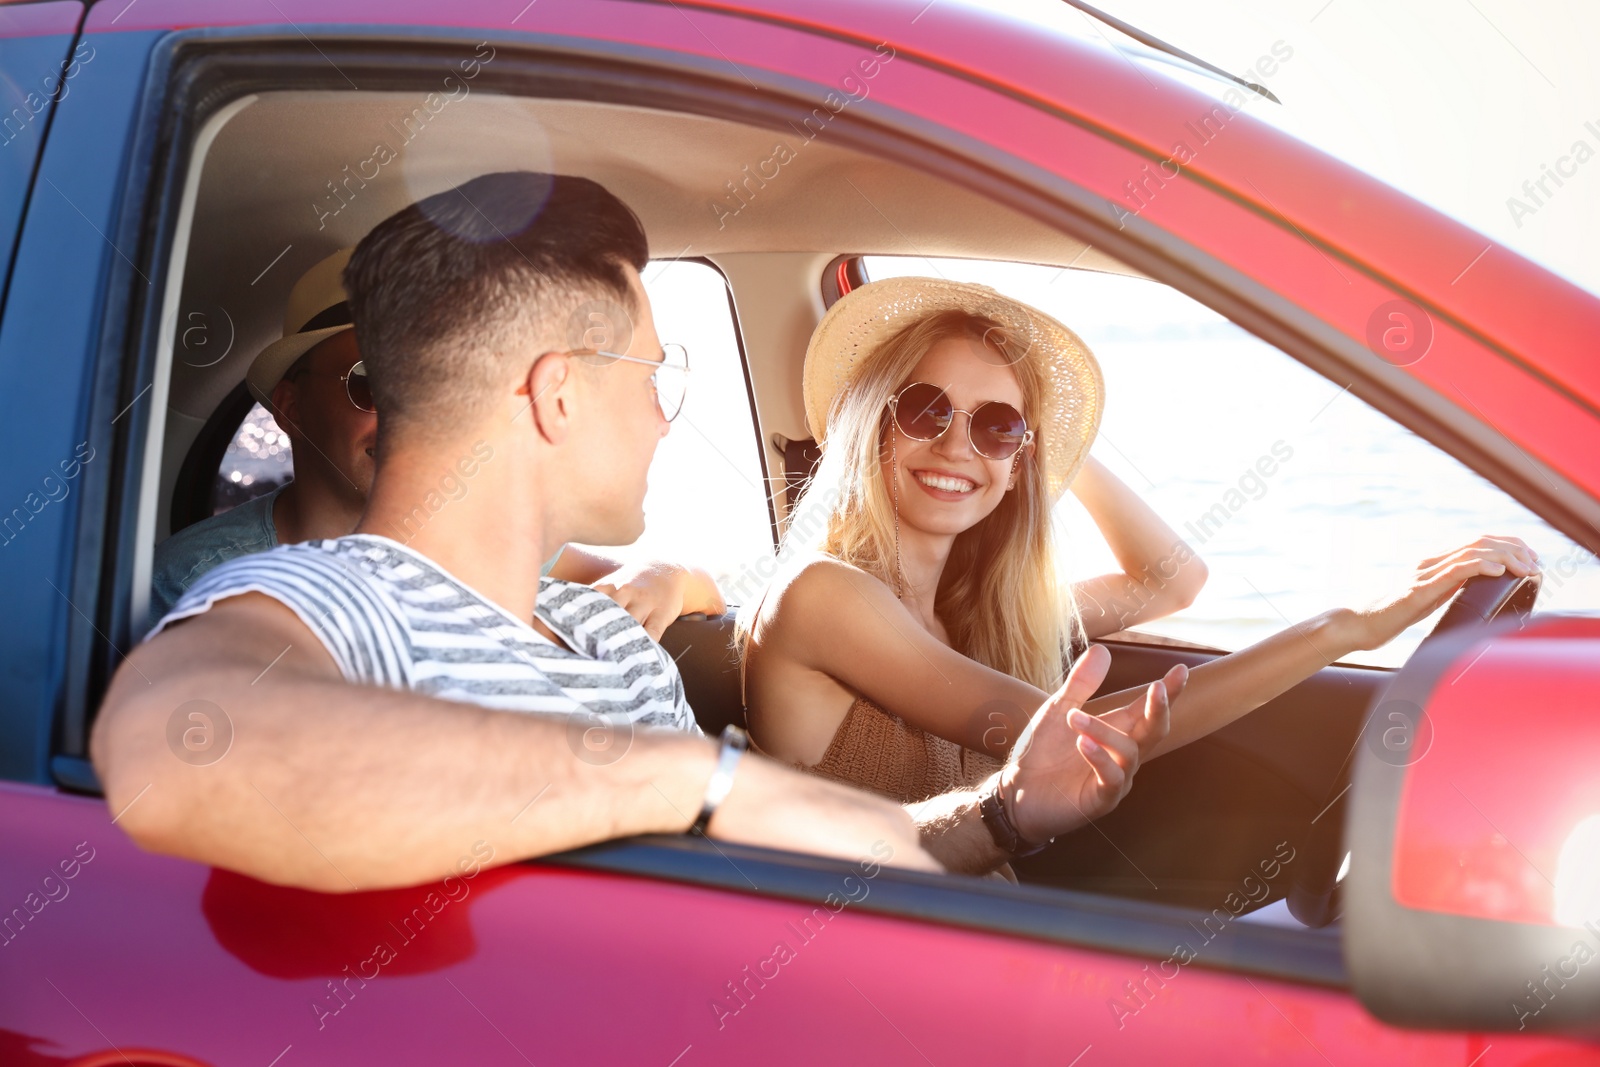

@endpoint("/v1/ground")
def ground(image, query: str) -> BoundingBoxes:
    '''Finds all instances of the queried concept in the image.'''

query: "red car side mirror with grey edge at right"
[1344,616,1600,1032]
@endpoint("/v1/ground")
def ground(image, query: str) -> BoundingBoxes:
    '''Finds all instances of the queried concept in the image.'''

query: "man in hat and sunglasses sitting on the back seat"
[150,248,726,638]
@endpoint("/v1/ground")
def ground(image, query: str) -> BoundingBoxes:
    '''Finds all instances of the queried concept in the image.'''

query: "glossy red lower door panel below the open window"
[12,785,1600,1067]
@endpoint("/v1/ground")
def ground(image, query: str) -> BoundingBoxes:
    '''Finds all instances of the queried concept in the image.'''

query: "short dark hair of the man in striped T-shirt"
[344,171,650,437]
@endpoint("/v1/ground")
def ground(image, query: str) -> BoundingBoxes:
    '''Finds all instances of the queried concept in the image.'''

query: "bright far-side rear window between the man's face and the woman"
[569,259,773,603]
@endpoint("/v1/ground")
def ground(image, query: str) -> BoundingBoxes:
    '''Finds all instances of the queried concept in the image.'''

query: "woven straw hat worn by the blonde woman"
[803,278,1106,499]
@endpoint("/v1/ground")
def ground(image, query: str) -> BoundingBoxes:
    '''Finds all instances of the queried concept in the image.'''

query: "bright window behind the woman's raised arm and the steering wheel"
[866,256,1600,665]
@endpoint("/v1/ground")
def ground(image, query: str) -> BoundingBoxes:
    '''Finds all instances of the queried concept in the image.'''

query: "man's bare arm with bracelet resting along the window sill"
[90,593,936,893]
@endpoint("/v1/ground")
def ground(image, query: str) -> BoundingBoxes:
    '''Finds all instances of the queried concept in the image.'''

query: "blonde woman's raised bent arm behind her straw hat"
[1072,456,1206,640]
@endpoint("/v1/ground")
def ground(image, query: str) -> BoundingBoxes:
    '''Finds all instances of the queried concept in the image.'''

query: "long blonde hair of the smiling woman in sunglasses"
[771,310,1082,691]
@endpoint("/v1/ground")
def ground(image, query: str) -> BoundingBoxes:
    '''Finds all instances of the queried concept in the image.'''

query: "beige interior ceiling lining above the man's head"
[170,91,1138,419]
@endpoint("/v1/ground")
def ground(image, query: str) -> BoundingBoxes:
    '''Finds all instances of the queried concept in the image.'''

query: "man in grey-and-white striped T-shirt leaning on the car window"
[91,173,1182,891]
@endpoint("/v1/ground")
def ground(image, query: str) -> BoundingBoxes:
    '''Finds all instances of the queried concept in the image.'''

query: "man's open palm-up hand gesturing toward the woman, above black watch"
[1000,645,1189,841]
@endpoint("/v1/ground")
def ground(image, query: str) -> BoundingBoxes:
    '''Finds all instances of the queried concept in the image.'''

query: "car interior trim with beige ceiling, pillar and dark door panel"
[131,81,1536,925]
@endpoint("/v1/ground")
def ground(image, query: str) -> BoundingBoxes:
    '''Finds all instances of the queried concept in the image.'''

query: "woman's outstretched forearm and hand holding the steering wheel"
[1083,537,1539,758]
